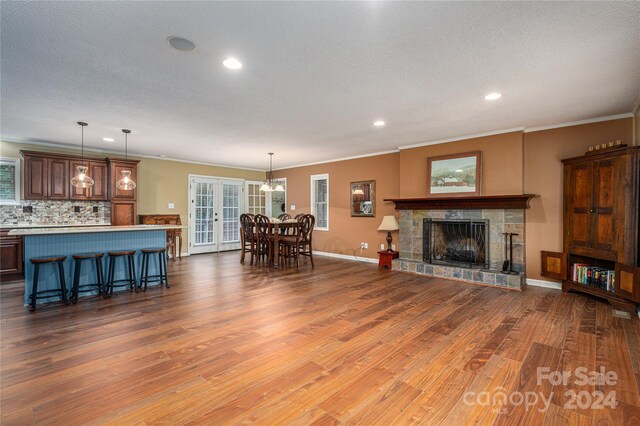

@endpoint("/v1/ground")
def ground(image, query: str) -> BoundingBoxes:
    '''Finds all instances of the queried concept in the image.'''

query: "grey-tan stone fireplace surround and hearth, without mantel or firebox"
[393,208,525,289]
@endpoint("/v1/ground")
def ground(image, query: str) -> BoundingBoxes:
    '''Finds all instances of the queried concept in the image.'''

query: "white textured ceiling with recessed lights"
[0,1,640,168]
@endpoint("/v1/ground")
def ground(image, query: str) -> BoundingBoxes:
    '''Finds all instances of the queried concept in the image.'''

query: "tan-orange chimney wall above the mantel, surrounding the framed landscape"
[400,132,523,197]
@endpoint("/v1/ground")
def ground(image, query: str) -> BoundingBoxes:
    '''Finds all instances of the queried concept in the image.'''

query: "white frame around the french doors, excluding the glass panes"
[187,173,246,255]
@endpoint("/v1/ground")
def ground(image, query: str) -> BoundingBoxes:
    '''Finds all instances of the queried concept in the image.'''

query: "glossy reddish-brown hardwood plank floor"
[0,252,640,425]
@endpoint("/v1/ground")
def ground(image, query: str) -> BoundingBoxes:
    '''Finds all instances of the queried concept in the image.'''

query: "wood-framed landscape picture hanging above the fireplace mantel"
[427,151,482,197]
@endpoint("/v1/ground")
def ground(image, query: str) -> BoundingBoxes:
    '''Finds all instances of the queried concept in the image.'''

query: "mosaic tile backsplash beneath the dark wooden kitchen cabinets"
[0,200,111,226]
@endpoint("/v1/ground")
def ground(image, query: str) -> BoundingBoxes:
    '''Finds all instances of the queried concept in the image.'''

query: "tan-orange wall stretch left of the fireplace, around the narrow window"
[274,154,399,258]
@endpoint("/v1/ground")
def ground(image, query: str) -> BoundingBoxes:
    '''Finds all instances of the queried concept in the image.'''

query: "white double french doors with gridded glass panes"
[189,176,244,254]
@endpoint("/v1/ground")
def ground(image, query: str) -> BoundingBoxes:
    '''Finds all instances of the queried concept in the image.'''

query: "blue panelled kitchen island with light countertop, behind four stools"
[8,225,186,305]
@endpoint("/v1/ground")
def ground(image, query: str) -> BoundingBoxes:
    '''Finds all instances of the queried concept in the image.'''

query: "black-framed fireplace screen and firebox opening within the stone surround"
[423,219,489,268]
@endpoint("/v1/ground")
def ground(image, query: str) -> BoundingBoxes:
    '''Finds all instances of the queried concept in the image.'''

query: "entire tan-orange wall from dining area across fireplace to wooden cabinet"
[276,118,634,279]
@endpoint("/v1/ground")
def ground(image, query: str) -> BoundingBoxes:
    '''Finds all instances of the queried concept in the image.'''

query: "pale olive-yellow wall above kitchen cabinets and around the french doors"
[0,142,265,252]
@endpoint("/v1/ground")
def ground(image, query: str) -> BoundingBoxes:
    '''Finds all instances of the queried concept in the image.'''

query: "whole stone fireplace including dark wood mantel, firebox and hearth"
[390,195,533,290]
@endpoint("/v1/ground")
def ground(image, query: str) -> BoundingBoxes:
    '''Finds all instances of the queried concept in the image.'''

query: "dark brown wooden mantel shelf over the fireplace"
[384,194,538,210]
